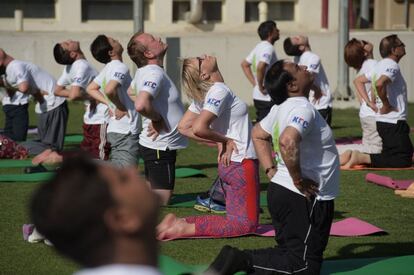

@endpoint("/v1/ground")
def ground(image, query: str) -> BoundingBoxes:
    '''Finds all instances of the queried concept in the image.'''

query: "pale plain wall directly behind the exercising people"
[0,29,414,106]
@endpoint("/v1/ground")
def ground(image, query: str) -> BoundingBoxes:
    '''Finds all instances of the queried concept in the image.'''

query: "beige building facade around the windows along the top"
[0,0,338,33]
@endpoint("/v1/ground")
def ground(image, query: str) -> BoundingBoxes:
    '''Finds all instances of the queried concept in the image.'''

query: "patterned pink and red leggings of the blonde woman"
[186,159,259,237]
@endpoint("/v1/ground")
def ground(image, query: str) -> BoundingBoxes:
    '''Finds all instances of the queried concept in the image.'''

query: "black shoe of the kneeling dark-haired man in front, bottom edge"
[206,245,253,275]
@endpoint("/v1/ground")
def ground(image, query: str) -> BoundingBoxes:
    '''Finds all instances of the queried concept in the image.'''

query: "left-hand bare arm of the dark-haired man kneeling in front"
[252,123,277,180]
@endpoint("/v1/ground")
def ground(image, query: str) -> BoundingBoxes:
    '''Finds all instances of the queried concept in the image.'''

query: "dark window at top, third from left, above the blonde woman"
[173,0,223,23]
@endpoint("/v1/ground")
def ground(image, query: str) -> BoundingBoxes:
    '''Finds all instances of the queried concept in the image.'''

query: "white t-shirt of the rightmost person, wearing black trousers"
[365,58,408,124]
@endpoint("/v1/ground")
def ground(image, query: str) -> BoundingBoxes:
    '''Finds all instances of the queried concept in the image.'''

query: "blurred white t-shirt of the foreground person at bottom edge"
[74,264,161,275]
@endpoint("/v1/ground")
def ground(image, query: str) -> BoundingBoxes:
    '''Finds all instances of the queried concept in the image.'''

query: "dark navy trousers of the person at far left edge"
[3,104,29,141]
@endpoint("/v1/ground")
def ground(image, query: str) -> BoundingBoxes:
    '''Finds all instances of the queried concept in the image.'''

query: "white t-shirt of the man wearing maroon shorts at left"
[57,59,108,124]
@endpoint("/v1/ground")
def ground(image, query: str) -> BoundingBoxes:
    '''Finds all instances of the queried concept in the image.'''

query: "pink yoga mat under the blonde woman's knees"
[163,218,385,241]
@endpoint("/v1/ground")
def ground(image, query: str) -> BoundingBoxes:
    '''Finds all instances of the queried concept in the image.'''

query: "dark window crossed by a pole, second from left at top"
[82,0,149,21]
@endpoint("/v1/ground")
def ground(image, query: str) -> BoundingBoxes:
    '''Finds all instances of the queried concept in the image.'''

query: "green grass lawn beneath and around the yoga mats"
[0,103,414,274]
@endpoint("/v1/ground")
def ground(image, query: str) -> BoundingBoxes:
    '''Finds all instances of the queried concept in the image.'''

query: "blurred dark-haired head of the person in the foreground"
[30,155,159,267]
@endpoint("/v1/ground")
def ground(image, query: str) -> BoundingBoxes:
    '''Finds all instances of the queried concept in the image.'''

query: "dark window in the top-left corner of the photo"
[0,0,55,18]
